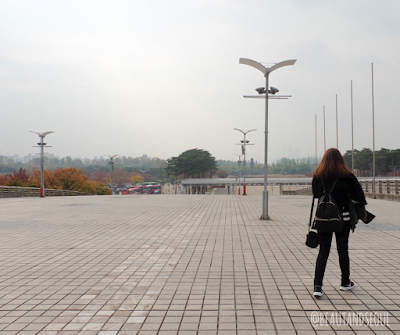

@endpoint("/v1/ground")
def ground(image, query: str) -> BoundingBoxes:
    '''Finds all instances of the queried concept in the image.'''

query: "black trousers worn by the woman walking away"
[314,222,350,286]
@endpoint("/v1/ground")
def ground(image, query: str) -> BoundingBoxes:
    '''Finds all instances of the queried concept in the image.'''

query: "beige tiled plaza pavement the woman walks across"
[0,195,400,335]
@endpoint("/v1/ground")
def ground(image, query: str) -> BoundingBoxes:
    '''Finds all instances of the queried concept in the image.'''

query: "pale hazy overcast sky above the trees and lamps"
[0,0,400,161]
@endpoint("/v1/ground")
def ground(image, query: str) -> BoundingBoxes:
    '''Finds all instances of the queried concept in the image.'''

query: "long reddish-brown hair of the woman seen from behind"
[313,148,351,179]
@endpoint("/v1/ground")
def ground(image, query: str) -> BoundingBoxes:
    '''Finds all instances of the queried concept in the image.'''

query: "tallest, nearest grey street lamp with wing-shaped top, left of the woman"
[239,58,296,220]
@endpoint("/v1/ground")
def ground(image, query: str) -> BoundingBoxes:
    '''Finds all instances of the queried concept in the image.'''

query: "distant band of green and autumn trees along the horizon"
[0,148,400,187]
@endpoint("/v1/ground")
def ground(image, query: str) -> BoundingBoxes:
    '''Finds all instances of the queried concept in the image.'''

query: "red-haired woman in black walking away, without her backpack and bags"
[312,148,367,297]
